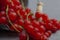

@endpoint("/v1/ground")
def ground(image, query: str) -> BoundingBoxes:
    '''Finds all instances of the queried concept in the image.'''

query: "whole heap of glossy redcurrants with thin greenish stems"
[0,0,60,40]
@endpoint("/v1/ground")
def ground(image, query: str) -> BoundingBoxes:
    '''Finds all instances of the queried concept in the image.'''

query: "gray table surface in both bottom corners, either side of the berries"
[0,30,60,40]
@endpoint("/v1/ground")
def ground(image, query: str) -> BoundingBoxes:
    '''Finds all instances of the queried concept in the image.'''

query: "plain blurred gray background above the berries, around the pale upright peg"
[29,0,60,20]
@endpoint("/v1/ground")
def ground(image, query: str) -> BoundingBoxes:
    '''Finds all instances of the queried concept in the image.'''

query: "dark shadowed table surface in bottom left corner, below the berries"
[0,32,19,40]
